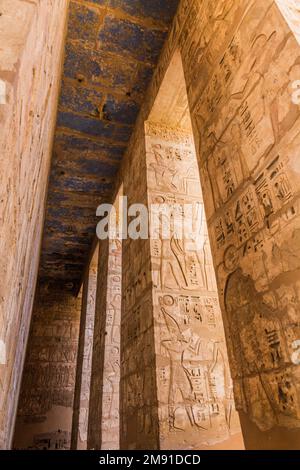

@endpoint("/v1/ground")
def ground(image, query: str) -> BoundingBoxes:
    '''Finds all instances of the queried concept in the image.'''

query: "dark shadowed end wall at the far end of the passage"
[14,287,81,450]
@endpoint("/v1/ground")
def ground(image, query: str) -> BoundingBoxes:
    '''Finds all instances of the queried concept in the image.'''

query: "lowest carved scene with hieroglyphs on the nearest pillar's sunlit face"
[160,295,234,436]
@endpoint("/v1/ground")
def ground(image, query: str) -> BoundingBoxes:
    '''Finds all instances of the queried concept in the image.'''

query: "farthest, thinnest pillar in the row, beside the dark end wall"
[71,249,98,450]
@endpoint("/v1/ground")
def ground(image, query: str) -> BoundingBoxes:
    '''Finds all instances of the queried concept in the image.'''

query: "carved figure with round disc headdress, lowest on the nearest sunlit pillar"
[160,296,232,430]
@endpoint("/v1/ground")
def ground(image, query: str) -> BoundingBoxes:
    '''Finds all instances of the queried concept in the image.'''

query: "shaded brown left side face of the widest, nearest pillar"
[120,138,159,449]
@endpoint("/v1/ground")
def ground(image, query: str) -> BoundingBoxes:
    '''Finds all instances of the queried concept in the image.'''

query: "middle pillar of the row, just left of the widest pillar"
[88,240,122,450]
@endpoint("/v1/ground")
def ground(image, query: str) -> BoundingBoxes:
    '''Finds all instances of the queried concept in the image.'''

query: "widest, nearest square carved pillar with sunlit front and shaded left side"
[121,123,241,449]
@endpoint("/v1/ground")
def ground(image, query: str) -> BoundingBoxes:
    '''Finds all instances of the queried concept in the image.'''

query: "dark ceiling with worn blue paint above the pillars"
[40,0,179,290]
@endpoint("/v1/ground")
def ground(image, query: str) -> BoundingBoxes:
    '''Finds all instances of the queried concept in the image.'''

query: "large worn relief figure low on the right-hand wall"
[225,268,300,431]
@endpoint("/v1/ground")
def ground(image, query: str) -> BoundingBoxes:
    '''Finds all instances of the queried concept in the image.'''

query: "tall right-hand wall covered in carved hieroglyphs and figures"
[187,1,300,431]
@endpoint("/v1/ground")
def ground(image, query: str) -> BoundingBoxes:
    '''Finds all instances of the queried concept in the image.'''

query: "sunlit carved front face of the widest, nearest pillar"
[146,123,239,448]
